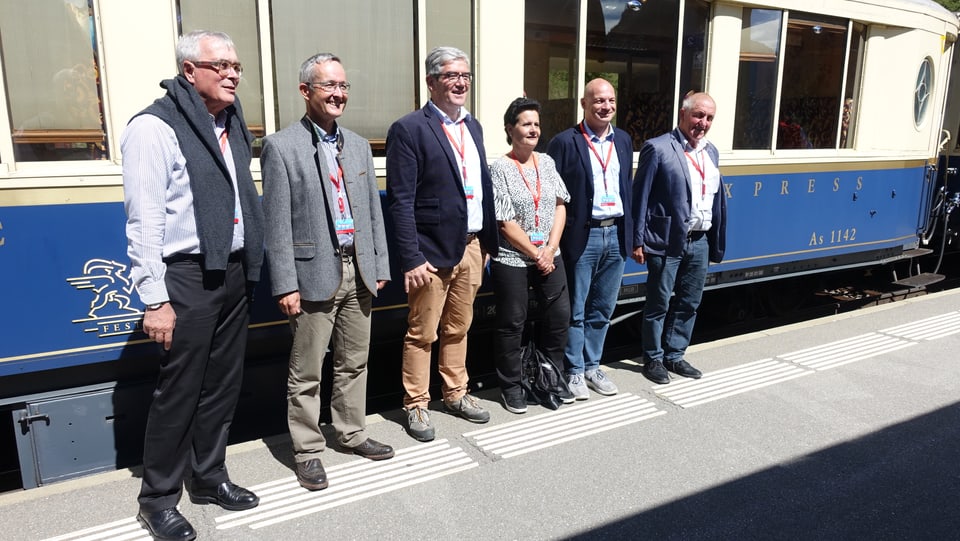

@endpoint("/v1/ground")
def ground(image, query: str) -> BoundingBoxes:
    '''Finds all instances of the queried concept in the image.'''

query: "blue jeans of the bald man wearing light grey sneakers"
[566,225,624,375]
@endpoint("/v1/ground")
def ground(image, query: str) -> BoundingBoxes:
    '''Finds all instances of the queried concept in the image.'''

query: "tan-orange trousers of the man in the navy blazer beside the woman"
[403,238,483,409]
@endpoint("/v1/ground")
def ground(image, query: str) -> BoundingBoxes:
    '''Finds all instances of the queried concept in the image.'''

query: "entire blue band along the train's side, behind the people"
[0,162,927,377]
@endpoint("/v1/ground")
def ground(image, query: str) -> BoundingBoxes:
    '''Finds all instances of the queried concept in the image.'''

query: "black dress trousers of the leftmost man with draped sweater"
[138,261,249,511]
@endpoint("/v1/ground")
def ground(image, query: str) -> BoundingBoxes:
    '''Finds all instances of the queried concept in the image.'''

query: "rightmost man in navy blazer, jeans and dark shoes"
[633,93,727,384]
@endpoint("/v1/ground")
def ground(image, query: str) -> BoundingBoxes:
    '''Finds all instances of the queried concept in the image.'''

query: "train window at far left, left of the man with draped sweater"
[0,0,108,161]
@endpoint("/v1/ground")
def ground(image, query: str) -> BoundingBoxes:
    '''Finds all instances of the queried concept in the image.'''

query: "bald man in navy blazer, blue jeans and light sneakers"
[547,79,633,400]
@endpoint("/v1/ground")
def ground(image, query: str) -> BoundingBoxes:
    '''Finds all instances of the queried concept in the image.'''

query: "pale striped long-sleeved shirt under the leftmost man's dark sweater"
[120,113,243,304]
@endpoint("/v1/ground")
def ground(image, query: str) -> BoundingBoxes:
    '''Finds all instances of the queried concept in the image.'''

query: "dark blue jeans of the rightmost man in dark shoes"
[643,235,710,362]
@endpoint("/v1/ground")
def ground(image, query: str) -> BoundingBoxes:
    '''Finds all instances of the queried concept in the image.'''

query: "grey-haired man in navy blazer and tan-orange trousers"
[387,47,497,441]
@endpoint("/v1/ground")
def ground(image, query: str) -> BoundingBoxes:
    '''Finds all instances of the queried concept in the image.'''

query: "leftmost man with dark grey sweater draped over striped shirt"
[121,31,263,540]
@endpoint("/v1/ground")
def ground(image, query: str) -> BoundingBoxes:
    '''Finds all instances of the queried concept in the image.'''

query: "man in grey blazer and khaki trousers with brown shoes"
[260,53,393,490]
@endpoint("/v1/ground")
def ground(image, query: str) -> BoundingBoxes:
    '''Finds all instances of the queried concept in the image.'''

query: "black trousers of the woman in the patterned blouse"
[490,257,570,394]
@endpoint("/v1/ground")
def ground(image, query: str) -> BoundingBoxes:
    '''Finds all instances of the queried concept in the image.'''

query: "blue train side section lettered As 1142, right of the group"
[624,163,929,284]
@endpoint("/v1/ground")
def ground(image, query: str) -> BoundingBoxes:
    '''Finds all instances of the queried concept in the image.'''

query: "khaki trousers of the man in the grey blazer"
[287,257,372,462]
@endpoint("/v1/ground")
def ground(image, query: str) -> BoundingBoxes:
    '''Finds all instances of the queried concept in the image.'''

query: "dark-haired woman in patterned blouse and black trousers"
[490,98,572,413]
